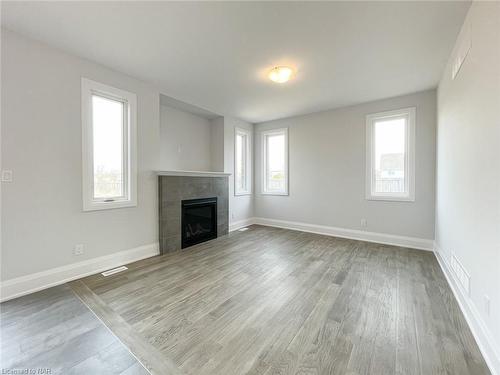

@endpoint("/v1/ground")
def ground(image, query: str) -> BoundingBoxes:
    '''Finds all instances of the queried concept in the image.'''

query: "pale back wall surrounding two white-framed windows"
[255,90,436,239]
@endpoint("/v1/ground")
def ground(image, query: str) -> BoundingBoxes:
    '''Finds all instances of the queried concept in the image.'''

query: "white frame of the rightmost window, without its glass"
[366,107,416,202]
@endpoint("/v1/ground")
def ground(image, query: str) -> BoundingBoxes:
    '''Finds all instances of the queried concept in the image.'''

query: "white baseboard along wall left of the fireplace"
[0,243,159,302]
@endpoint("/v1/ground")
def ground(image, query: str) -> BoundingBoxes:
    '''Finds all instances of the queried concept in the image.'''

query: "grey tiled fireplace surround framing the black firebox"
[158,175,229,254]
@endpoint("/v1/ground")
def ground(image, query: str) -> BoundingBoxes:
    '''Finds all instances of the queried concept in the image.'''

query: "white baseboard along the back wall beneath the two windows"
[252,217,434,251]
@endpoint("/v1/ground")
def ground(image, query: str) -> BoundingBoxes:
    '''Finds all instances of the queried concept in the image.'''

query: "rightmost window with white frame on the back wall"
[366,108,415,201]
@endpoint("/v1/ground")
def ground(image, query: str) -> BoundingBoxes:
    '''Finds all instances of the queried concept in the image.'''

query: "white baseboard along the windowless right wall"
[434,243,500,375]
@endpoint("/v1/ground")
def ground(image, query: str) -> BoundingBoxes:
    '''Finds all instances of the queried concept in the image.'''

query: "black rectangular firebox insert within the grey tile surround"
[181,197,217,249]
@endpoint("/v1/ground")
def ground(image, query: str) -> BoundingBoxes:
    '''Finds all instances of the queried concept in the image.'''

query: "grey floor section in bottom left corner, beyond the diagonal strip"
[0,285,149,375]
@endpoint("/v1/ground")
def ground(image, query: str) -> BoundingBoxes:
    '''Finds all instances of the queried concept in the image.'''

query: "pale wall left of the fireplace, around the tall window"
[1,29,160,280]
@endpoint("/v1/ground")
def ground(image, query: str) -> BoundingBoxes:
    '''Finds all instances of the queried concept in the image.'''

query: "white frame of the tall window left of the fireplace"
[81,77,137,211]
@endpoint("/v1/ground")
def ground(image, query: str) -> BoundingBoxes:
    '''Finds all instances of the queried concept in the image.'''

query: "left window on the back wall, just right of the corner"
[262,129,288,195]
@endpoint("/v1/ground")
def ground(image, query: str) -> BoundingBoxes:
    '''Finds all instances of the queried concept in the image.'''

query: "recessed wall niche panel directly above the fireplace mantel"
[160,105,212,171]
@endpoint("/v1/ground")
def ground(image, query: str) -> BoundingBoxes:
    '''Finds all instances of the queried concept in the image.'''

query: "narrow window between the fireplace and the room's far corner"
[234,128,252,195]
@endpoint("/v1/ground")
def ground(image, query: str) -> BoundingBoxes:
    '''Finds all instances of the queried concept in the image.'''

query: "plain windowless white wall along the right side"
[436,2,500,374]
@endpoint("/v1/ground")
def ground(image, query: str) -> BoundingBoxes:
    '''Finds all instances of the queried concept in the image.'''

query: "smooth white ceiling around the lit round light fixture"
[2,1,470,122]
